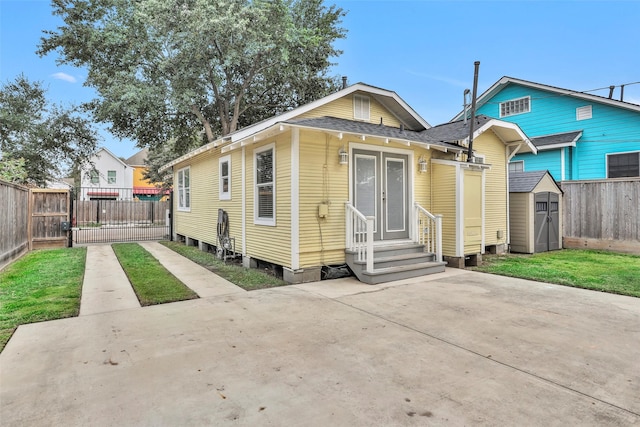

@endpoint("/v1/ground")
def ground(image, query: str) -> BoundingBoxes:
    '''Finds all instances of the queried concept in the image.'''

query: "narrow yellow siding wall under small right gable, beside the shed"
[474,132,508,246]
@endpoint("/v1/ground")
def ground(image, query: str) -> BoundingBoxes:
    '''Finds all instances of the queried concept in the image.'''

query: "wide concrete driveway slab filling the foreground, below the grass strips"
[0,270,640,426]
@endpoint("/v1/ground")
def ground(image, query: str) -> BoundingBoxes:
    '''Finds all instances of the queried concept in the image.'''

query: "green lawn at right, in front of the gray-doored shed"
[474,249,640,297]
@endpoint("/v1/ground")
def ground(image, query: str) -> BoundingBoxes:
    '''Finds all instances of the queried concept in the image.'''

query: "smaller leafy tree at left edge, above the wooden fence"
[0,75,98,186]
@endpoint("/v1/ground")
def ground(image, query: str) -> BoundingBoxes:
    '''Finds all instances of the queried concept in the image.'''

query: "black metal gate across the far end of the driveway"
[71,187,171,244]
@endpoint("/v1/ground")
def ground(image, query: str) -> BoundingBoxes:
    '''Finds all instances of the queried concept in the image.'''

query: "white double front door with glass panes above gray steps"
[351,149,410,240]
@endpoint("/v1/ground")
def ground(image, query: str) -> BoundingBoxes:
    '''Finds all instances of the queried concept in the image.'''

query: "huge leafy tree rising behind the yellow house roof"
[39,0,345,159]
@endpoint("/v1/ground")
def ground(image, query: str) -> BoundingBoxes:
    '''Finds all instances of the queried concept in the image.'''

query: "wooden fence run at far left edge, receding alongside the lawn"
[0,181,29,268]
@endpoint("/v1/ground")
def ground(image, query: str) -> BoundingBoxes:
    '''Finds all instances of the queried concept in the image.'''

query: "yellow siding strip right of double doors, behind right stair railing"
[431,164,457,256]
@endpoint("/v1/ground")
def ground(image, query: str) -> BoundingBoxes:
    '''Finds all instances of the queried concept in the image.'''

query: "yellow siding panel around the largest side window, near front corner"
[245,132,291,268]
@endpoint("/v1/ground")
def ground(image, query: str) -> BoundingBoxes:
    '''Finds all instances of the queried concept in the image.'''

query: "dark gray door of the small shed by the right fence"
[534,193,560,252]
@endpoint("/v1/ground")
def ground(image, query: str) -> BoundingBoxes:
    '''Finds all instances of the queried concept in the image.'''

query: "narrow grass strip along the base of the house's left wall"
[160,241,287,291]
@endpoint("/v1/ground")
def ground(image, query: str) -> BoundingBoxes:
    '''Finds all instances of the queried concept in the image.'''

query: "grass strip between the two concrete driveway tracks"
[111,243,198,306]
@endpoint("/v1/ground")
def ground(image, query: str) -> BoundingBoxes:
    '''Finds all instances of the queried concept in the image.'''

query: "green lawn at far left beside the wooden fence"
[0,248,87,351]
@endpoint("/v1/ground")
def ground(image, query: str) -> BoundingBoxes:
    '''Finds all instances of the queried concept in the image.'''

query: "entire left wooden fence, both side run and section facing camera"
[0,181,70,268]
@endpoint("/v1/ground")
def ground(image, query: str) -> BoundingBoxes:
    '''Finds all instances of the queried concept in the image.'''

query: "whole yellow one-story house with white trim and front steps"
[163,83,535,283]
